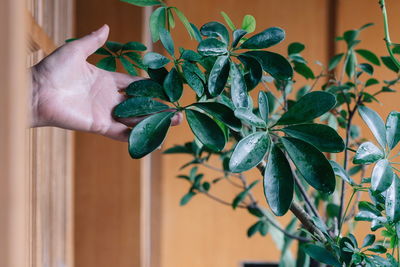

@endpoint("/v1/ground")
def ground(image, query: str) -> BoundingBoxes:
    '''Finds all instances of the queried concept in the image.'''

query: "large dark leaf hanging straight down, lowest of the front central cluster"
[264,144,294,216]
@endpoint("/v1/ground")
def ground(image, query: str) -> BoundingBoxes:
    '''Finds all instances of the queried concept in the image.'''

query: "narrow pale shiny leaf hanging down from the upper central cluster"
[230,62,249,108]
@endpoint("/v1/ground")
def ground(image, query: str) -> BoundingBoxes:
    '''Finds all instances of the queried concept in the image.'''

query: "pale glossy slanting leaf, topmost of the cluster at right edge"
[358,106,386,149]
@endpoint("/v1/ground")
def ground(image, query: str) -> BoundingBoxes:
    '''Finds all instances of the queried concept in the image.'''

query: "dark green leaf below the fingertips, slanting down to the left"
[129,112,174,159]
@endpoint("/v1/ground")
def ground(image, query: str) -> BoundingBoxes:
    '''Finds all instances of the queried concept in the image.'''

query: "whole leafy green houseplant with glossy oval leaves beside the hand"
[90,0,400,266]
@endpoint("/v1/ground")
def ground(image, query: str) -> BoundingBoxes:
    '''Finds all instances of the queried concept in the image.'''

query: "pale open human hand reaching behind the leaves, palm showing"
[31,25,181,141]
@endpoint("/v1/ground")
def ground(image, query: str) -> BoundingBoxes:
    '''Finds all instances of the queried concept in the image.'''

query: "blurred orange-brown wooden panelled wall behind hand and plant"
[19,0,400,267]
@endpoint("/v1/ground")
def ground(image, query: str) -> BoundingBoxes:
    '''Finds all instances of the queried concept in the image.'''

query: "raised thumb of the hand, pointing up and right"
[73,24,110,57]
